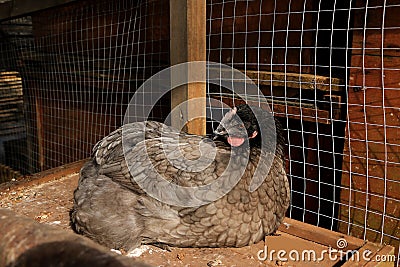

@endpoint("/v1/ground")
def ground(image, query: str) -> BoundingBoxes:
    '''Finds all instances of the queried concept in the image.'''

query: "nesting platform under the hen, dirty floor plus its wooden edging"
[0,162,394,266]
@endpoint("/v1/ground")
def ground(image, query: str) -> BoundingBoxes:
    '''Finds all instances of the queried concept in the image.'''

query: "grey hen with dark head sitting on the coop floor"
[71,105,290,251]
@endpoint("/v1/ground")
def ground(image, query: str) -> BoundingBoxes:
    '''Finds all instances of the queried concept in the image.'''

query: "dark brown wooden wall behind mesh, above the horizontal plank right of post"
[207,0,318,73]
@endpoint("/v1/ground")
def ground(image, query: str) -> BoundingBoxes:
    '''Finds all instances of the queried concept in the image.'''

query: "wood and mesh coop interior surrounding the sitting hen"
[0,0,400,266]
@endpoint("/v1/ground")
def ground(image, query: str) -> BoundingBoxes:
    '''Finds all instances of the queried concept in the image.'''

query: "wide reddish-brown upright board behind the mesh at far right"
[339,1,400,253]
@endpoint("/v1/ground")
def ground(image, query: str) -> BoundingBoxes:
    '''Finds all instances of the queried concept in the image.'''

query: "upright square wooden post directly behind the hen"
[170,0,206,135]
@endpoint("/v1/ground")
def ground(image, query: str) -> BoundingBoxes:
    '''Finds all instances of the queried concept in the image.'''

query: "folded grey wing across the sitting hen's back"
[93,122,239,203]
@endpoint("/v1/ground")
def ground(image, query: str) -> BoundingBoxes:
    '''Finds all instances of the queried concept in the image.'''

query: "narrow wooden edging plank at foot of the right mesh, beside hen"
[279,218,365,250]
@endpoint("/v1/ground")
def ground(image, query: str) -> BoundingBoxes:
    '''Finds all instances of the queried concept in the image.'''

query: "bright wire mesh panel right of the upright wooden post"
[207,0,400,260]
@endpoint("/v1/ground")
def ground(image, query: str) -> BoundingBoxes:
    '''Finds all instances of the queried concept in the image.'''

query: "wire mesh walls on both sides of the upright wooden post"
[0,0,400,264]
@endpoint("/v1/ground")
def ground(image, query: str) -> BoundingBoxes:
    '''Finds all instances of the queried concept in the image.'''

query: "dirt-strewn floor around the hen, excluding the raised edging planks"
[0,174,346,267]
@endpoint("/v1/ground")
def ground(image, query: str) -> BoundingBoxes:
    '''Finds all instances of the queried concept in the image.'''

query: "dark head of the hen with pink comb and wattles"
[214,104,261,147]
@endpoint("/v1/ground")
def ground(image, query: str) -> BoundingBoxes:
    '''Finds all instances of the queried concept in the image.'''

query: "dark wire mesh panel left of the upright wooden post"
[0,0,170,176]
